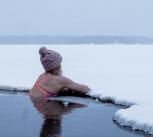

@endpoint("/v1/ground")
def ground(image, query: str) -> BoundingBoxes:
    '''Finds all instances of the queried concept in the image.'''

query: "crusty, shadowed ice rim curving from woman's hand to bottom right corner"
[88,92,153,135]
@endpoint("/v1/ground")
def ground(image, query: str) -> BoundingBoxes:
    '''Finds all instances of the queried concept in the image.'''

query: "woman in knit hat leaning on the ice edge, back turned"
[29,47,90,98]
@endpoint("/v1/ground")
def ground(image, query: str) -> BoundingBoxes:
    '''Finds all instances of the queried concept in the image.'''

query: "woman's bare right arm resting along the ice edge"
[60,76,90,94]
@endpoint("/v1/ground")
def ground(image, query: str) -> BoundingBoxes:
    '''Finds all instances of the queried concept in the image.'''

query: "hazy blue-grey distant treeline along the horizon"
[0,35,153,44]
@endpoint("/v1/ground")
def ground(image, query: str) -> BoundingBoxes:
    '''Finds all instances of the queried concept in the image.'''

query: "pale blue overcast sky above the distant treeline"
[0,0,153,37]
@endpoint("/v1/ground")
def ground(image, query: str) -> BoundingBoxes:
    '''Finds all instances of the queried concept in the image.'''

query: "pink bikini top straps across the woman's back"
[30,77,57,98]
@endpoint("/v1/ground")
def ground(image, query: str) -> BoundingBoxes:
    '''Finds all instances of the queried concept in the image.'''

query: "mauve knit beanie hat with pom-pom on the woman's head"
[39,47,62,71]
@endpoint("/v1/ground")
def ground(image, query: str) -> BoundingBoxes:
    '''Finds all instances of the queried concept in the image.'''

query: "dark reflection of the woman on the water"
[31,98,85,137]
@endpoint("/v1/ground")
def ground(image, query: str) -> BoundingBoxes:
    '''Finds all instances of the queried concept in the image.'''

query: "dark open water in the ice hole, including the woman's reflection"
[0,92,151,137]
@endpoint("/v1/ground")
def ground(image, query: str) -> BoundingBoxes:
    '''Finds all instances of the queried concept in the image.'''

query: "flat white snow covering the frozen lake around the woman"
[0,44,153,134]
